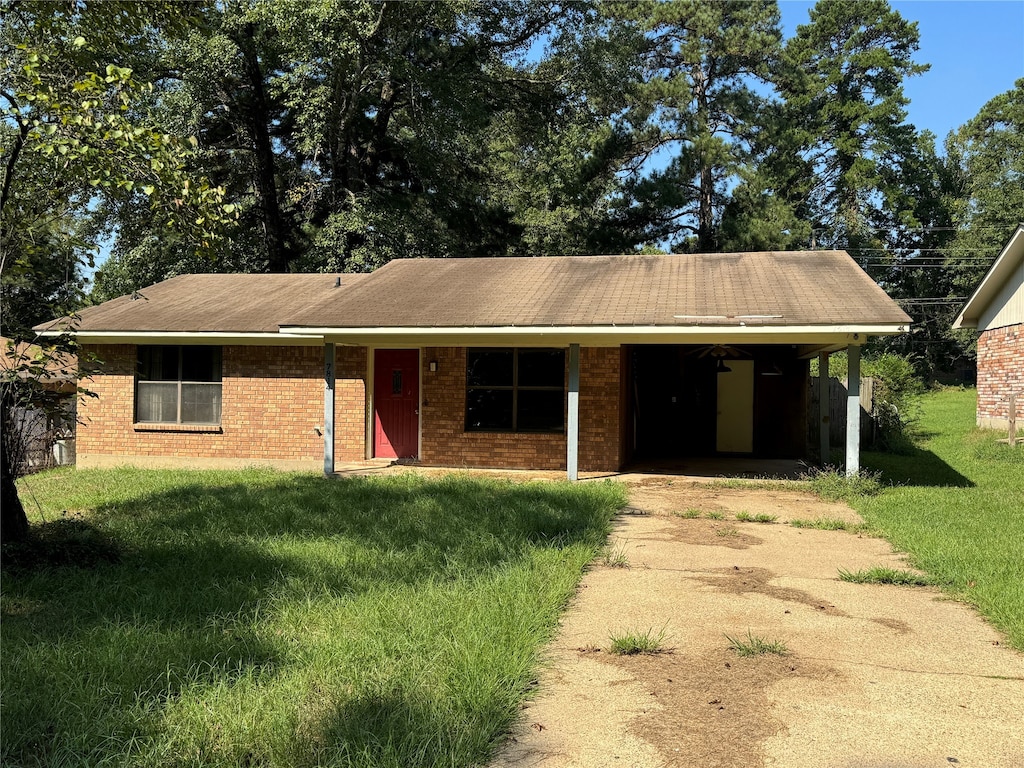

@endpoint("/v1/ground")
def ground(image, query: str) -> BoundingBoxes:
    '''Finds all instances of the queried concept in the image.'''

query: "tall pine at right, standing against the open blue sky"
[780,0,928,257]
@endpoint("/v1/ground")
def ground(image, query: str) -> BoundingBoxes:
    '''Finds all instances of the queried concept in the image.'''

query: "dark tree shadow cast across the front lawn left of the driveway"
[0,474,614,765]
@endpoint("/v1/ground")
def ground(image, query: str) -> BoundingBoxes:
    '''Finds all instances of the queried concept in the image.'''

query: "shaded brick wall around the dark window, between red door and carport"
[420,347,621,472]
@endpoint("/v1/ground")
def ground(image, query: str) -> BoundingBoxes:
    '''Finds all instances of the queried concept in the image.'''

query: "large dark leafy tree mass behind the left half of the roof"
[99,0,630,296]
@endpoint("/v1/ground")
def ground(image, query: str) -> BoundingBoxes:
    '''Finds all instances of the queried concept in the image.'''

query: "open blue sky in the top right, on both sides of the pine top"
[779,0,1024,144]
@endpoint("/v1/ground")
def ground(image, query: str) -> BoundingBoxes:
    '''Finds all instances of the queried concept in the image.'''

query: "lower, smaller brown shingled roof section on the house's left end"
[37,274,370,333]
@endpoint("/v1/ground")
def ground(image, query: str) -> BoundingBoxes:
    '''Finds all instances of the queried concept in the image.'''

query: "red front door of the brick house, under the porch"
[374,349,420,459]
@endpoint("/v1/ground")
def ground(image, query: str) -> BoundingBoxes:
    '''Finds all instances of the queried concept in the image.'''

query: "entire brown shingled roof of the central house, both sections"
[47,251,910,333]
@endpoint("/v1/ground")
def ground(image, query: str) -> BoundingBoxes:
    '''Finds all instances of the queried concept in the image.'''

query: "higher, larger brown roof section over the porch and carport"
[280,251,910,328]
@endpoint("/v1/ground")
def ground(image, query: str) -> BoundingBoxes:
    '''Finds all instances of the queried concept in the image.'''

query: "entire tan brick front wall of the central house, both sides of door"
[77,344,623,472]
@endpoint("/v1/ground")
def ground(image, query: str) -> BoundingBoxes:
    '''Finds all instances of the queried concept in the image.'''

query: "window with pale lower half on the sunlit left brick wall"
[135,346,220,424]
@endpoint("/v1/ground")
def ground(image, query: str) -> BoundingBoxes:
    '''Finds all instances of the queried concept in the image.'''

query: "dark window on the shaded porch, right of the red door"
[466,349,565,432]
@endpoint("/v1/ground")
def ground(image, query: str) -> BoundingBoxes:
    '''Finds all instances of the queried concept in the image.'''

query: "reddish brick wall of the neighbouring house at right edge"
[978,323,1024,429]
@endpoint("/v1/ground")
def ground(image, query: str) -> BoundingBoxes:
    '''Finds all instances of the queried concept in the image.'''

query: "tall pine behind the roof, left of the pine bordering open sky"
[610,0,781,252]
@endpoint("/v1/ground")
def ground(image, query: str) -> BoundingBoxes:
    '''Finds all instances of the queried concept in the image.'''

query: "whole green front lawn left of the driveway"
[0,470,626,768]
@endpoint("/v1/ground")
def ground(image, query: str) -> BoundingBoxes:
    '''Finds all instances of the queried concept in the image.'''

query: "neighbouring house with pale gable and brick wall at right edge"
[953,224,1024,430]
